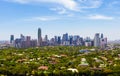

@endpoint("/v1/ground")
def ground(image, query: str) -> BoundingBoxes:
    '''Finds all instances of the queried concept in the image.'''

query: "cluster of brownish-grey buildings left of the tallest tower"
[10,34,37,48]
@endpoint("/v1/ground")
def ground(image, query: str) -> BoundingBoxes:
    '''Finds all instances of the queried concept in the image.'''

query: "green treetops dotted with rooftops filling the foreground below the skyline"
[0,46,120,76]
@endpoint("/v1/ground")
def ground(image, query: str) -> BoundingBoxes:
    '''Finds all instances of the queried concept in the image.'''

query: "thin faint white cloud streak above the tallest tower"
[23,16,59,21]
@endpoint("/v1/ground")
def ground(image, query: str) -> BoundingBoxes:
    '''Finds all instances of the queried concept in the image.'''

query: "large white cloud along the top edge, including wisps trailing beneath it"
[5,0,102,17]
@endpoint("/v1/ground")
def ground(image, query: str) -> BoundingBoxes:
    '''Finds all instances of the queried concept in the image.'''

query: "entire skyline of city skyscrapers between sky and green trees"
[10,28,107,49]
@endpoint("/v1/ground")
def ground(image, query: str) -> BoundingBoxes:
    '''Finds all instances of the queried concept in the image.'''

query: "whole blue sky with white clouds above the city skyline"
[0,0,120,40]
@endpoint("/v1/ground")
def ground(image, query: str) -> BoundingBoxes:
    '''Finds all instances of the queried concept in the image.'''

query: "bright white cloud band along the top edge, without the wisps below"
[5,0,102,11]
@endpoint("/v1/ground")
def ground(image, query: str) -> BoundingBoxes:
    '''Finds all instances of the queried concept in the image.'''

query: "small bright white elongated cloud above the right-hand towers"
[88,15,114,20]
